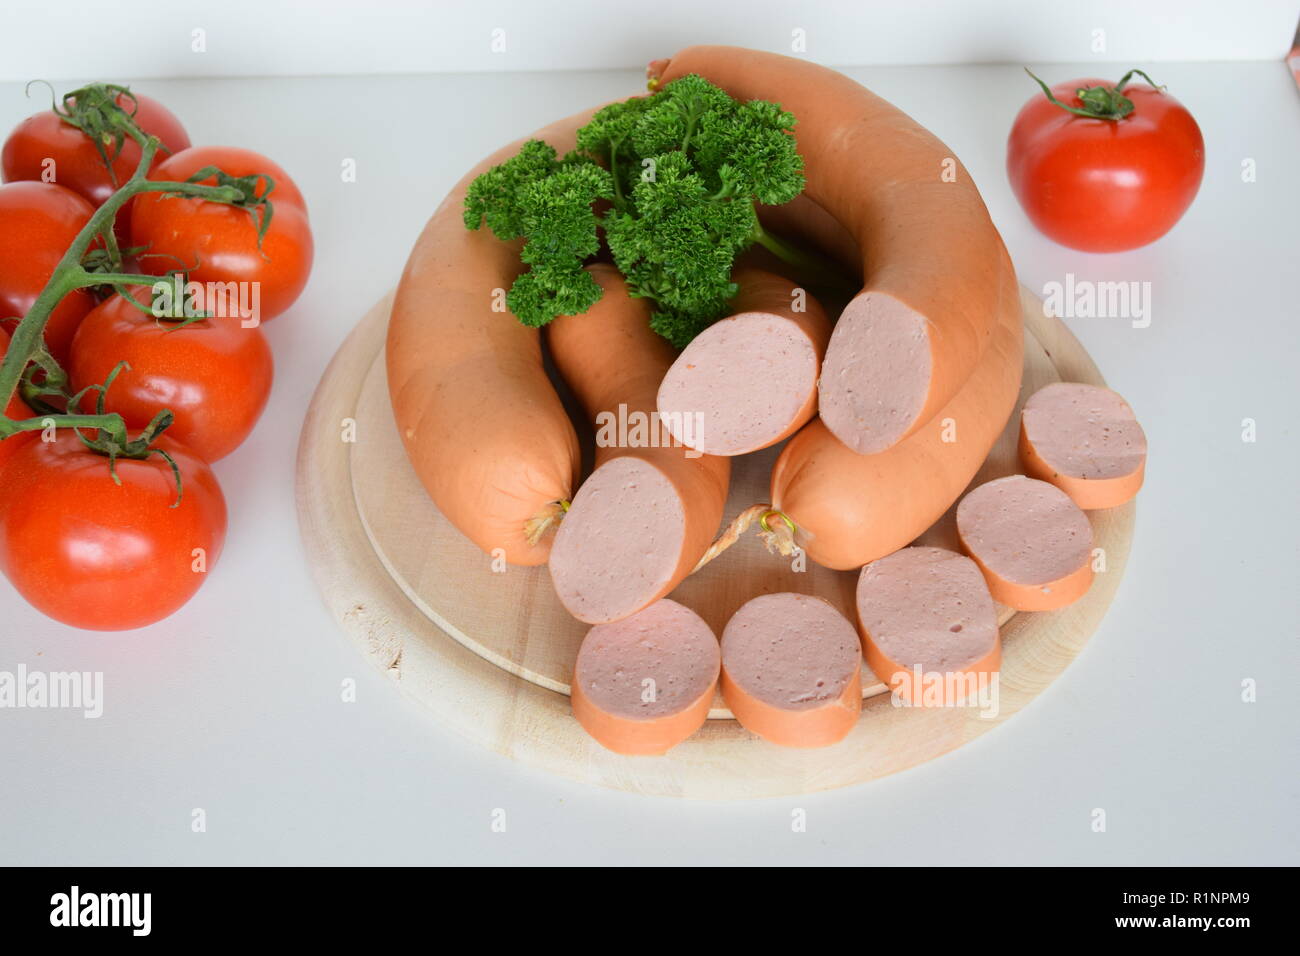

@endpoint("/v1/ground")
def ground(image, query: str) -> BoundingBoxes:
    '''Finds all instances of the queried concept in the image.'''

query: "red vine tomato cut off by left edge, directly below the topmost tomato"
[0,182,95,363]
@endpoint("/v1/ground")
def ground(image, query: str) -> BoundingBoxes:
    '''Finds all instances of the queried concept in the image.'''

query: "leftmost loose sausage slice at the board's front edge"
[572,600,720,754]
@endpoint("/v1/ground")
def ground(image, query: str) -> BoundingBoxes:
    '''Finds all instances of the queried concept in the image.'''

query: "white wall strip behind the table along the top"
[0,0,1296,82]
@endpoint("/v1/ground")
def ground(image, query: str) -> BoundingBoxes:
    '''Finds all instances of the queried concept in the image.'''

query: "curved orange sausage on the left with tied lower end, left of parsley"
[386,111,594,564]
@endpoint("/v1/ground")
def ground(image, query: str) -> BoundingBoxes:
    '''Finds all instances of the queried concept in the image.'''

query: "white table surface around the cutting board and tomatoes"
[0,62,1300,865]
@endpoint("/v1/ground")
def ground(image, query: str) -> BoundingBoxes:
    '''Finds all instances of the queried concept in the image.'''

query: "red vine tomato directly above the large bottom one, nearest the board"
[68,287,273,462]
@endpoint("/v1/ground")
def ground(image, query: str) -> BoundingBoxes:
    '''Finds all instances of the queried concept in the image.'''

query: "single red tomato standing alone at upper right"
[1006,70,1205,252]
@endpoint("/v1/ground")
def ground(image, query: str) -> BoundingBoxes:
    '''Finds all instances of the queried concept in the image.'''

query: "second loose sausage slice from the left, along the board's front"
[722,593,862,747]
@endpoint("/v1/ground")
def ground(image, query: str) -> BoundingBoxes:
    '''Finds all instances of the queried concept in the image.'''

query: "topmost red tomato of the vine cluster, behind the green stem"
[0,94,190,237]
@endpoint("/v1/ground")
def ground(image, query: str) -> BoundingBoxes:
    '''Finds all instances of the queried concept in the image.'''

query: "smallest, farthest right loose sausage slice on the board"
[1021,382,1147,511]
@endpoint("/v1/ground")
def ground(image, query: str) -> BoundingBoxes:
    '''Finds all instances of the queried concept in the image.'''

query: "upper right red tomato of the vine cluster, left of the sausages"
[131,146,313,321]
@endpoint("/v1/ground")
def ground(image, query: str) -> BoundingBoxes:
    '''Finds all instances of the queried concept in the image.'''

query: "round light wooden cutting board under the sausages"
[298,290,1134,799]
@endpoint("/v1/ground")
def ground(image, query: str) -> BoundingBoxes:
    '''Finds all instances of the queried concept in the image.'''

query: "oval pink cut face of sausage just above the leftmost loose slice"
[550,455,686,624]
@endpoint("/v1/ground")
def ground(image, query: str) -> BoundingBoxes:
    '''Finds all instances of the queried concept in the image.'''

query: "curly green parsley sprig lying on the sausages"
[465,75,842,347]
